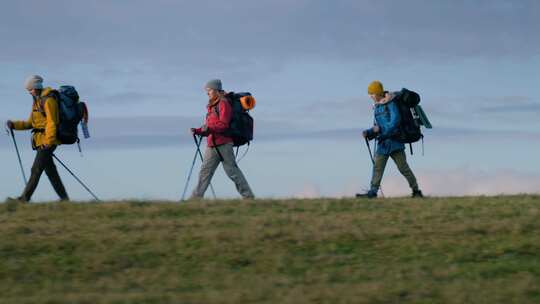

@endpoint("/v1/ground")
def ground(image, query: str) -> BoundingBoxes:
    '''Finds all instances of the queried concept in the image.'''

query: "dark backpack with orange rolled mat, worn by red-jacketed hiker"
[214,92,256,147]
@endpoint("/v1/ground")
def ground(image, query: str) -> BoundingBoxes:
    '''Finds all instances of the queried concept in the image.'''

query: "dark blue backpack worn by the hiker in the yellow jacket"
[42,85,88,145]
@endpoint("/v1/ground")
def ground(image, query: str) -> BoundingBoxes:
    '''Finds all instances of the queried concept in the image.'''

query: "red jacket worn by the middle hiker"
[197,97,233,147]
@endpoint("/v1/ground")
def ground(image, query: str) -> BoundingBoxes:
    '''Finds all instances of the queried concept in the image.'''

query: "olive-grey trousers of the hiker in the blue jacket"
[371,150,418,192]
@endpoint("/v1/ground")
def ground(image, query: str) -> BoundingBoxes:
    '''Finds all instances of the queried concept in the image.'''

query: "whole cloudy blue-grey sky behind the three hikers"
[0,0,540,201]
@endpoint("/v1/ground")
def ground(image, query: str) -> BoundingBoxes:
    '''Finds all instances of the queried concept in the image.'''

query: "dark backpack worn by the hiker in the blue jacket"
[394,88,432,154]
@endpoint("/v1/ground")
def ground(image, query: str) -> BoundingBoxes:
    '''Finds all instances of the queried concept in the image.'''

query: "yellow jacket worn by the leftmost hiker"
[13,88,60,148]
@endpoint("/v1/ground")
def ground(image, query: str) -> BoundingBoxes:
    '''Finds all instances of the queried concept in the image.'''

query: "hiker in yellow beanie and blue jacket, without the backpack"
[356,81,423,198]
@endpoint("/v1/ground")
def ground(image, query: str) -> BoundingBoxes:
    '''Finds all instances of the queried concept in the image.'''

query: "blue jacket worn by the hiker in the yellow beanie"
[366,93,405,155]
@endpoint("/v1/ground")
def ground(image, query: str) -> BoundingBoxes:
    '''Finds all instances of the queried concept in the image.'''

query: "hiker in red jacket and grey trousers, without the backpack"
[191,79,255,199]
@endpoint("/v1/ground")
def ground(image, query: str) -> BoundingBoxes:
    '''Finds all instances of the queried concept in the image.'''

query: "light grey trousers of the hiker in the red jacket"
[191,143,255,198]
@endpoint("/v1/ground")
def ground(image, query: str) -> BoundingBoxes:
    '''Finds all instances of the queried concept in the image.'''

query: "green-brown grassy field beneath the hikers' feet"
[0,196,540,304]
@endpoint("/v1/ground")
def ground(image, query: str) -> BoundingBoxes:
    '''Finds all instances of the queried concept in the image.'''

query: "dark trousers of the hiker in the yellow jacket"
[21,147,69,201]
